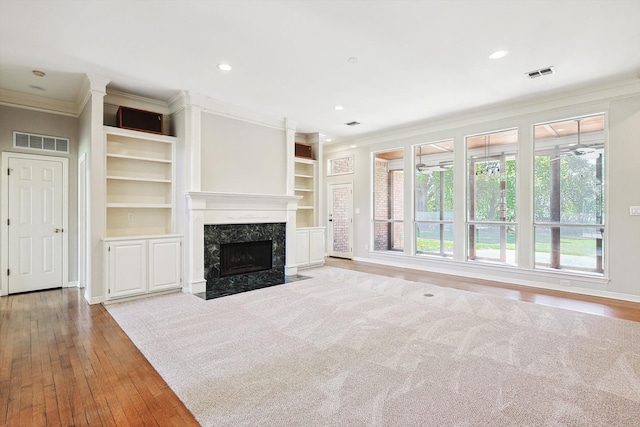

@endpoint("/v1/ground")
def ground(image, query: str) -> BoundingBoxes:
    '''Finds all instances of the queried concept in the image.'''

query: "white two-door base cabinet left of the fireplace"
[104,236,182,300]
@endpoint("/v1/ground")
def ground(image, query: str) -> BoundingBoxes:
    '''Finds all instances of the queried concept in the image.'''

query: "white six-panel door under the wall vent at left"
[7,157,65,293]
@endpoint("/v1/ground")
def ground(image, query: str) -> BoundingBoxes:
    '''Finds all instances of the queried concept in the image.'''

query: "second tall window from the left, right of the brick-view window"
[414,140,453,256]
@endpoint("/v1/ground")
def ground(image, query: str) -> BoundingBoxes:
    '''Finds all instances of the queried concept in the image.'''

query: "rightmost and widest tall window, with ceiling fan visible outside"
[534,114,605,274]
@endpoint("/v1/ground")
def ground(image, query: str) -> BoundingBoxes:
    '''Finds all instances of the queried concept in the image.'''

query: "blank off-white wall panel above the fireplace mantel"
[201,113,287,195]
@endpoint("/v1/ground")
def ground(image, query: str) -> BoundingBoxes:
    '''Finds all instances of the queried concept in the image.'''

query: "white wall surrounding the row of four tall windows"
[324,85,640,301]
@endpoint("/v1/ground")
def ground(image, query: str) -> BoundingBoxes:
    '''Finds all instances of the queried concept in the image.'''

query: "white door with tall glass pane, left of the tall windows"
[327,183,353,258]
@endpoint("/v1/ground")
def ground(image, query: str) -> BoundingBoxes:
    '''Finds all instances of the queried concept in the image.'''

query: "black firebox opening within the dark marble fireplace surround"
[220,240,273,277]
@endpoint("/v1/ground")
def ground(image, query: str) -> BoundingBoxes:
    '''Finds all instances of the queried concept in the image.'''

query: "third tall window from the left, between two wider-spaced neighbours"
[466,129,518,265]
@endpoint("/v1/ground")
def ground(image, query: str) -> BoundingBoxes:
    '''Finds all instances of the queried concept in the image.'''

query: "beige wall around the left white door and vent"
[0,105,78,282]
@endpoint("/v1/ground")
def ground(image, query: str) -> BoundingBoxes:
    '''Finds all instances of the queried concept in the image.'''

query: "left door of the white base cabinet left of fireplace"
[105,240,147,299]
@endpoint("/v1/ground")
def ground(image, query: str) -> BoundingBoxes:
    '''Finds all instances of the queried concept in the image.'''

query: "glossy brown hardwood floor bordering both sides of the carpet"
[0,258,640,427]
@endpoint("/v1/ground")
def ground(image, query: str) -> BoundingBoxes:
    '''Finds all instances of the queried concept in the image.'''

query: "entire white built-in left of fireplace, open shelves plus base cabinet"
[104,126,182,299]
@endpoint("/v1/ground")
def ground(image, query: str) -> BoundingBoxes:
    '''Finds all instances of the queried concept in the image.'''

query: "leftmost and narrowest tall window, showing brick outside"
[373,149,404,251]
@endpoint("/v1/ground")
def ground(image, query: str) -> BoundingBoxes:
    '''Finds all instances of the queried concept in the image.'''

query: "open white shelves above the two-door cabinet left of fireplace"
[104,126,176,237]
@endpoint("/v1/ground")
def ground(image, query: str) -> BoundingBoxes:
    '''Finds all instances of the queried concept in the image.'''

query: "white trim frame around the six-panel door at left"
[0,151,69,296]
